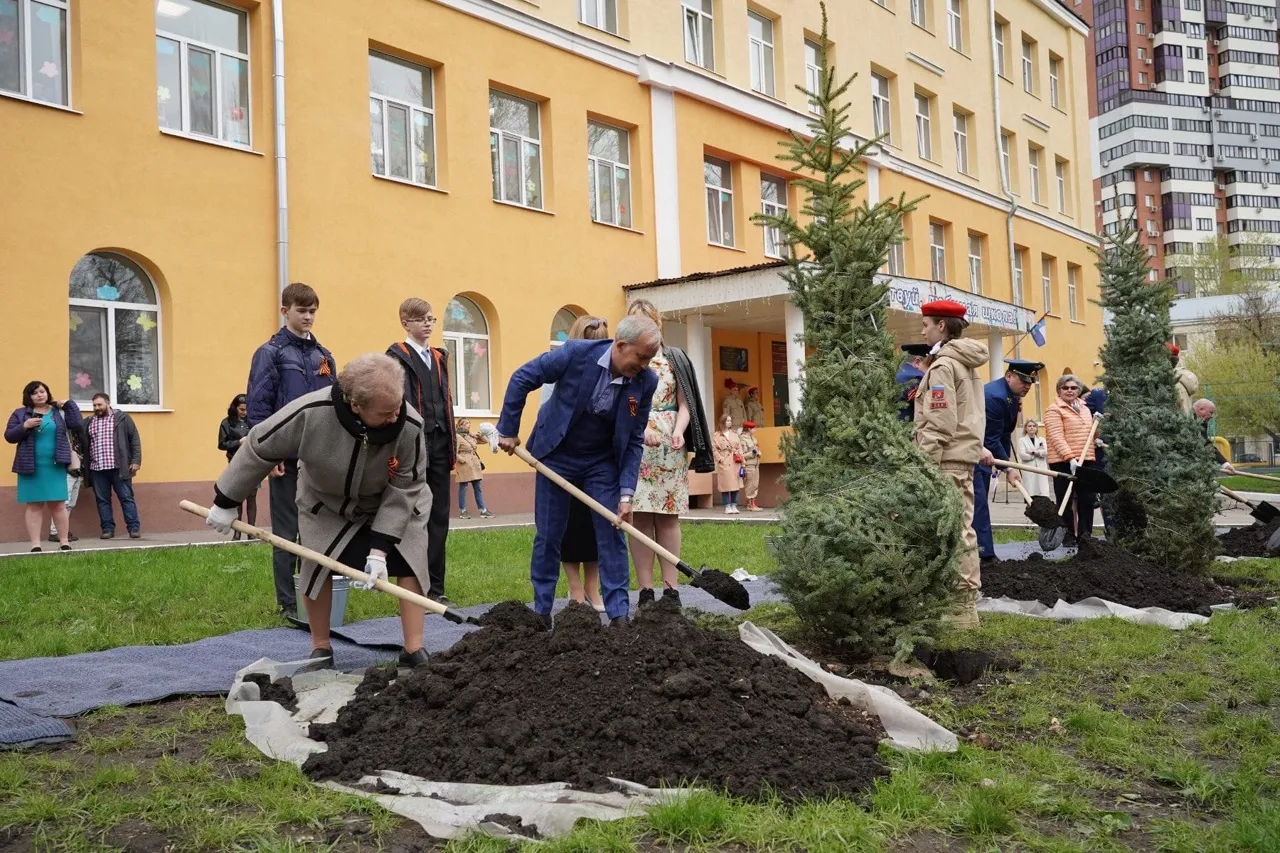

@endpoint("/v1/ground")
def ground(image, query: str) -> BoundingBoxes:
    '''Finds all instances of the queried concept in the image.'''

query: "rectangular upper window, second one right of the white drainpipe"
[489,88,543,210]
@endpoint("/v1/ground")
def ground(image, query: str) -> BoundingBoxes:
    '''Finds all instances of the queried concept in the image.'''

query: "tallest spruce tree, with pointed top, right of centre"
[755,6,963,660]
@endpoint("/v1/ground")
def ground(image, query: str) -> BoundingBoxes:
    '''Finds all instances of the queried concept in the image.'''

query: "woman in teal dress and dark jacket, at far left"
[4,382,84,551]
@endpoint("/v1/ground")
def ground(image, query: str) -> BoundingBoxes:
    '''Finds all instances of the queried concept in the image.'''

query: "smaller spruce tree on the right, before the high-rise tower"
[1098,222,1217,571]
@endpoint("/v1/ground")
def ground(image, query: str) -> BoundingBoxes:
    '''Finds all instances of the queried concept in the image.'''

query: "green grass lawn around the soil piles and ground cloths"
[0,525,1280,853]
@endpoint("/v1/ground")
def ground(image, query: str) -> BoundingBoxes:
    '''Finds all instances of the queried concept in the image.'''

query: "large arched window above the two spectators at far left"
[69,252,160,409]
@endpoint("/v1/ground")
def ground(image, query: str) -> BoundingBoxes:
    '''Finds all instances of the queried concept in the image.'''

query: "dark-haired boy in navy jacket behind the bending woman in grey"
[244,282,338,616]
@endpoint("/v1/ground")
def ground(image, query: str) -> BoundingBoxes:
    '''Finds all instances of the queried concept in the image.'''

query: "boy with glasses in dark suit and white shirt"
[387,296,461,605]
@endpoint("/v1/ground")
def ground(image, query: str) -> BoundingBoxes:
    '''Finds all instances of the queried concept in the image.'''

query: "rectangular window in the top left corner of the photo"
[0,0,70,106]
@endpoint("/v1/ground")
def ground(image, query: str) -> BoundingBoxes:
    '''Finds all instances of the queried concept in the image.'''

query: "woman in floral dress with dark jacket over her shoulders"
[627,300,714,605]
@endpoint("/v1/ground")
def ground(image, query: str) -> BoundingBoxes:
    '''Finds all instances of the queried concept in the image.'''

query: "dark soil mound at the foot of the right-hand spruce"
[982,539,1235,616]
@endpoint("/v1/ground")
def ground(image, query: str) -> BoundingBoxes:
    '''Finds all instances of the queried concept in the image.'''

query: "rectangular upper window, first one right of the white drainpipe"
[369,53,435,187]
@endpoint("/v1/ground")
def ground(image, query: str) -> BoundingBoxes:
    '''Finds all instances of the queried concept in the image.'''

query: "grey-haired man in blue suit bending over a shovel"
[498,315,662,625]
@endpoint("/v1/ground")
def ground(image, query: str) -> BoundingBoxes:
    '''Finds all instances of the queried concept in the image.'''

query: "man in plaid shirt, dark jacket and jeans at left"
[88,392,142,539]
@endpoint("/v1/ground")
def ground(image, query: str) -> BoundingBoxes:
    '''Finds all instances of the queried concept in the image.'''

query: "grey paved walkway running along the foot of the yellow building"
[0,493,1259,557]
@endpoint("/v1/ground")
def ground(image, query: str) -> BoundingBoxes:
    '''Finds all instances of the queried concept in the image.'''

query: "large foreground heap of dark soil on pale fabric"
[303,599,887,799]
